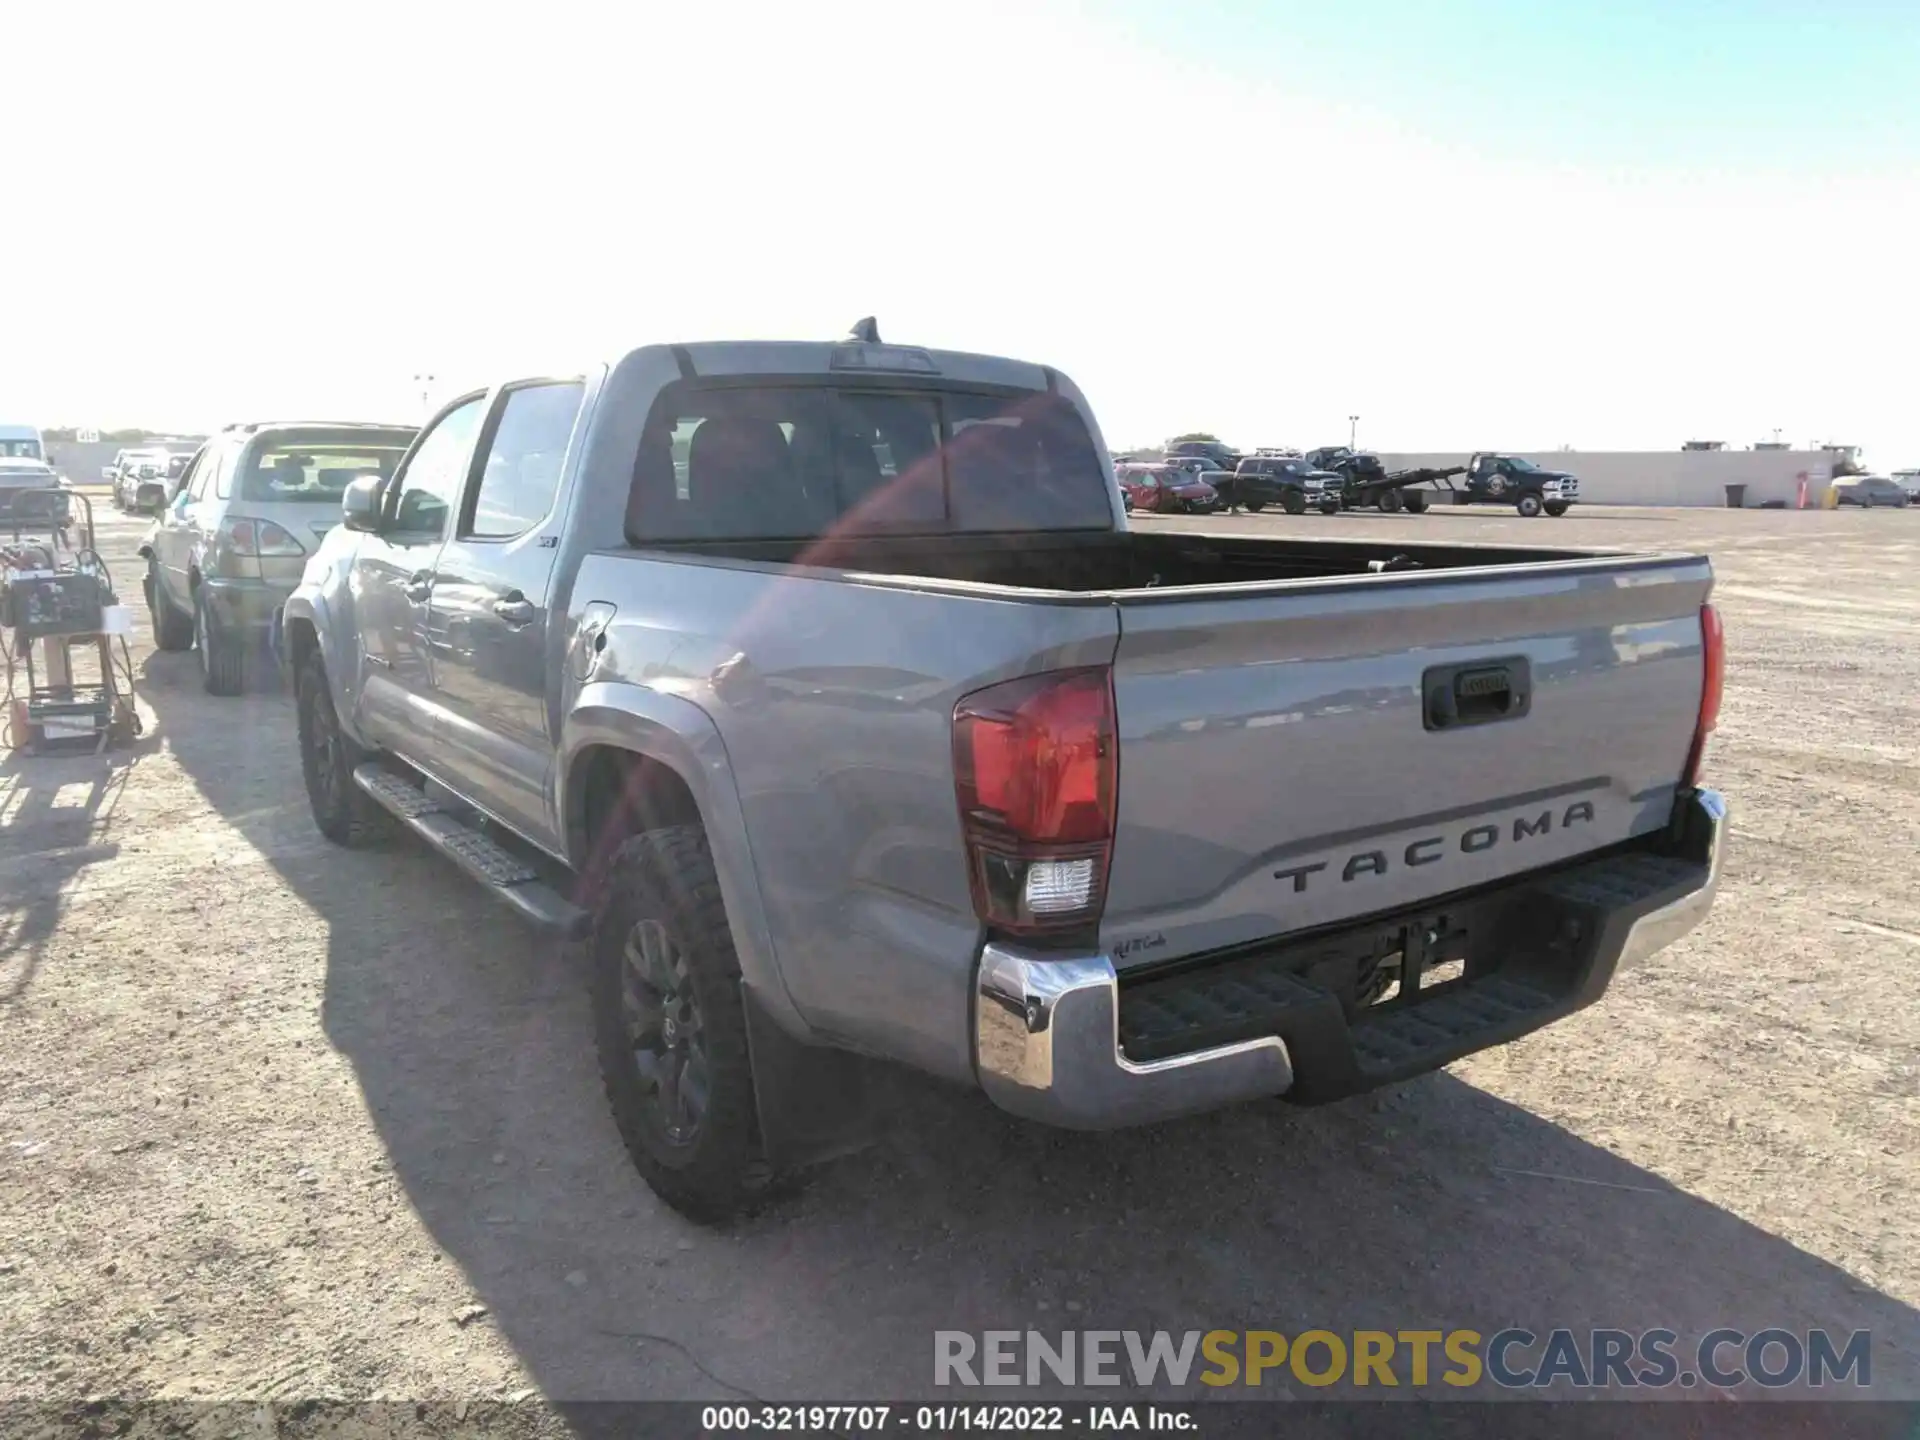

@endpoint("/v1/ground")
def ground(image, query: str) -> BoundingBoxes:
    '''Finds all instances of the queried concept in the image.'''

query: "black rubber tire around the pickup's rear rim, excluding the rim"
[593,826,774,1223]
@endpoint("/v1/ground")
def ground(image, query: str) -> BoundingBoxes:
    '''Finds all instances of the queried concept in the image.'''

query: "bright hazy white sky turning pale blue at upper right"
[0,0,1920,468]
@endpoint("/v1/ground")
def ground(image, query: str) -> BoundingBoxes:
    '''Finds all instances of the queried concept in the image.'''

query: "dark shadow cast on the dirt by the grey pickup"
[146,657,1920,1400]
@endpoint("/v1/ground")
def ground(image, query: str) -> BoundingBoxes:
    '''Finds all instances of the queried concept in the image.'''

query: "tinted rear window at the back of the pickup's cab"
[628,382,1112,543]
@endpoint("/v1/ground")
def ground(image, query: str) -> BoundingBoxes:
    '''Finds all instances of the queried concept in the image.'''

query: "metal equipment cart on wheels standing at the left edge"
[0,490,140,755]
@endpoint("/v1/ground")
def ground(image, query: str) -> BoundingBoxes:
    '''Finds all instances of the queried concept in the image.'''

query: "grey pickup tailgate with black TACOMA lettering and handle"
[1102,557,1713,968]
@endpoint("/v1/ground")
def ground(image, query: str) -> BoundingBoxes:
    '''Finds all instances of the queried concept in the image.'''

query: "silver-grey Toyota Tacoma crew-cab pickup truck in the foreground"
[280,323,1726,1217]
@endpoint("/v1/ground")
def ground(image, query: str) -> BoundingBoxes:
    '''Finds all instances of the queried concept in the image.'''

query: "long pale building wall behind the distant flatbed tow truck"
[1380,449,1834,507]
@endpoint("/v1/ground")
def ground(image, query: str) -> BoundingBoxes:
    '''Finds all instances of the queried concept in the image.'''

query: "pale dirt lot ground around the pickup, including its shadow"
[0,509,1920,1400]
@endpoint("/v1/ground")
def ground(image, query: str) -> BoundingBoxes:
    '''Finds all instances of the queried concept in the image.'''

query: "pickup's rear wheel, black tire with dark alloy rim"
[593,826,774,1221]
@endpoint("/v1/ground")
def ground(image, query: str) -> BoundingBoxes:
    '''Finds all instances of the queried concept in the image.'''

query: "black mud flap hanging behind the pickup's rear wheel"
[739,985,879,1169]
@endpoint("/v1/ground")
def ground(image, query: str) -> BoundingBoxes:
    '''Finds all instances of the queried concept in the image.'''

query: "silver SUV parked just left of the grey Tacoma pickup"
[140,422,415,695]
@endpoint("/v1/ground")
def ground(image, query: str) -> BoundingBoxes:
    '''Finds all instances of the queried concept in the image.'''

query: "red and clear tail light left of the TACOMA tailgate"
[954,668,1119,933]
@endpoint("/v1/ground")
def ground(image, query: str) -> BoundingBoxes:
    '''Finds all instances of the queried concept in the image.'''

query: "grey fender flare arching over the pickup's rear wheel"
[551,682,814,1043]
